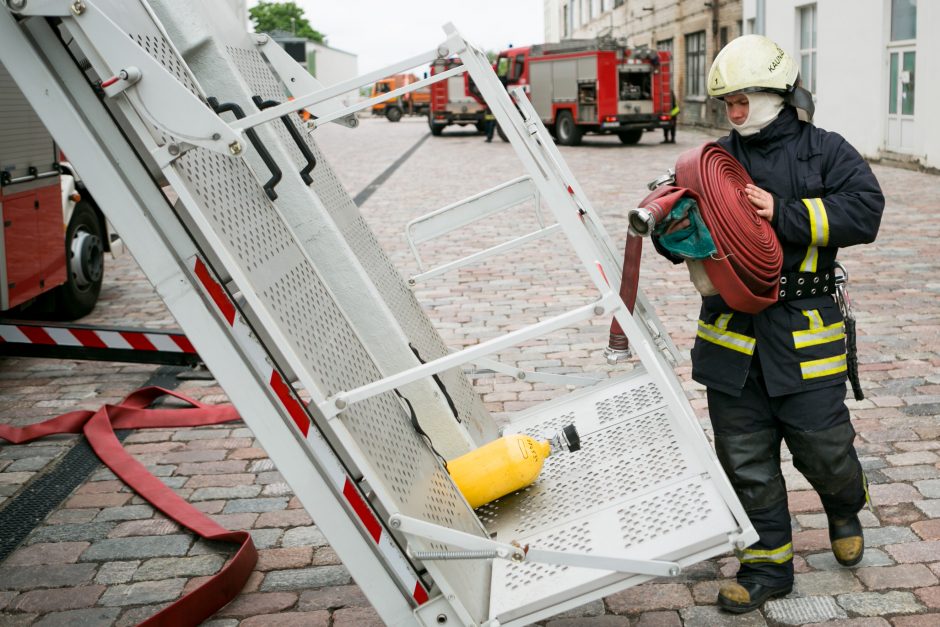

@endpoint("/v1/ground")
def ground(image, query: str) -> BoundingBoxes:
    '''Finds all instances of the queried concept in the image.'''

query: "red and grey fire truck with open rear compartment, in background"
[496,37,672,146]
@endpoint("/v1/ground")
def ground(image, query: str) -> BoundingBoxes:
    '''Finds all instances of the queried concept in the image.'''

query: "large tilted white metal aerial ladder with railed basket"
[0,0,757,627]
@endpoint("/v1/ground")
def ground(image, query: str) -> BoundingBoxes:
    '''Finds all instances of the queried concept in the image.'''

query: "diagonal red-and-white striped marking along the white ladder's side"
[190,256,428,605]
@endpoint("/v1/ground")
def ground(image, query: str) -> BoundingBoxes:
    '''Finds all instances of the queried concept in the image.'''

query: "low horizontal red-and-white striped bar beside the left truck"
[0,324,196,354]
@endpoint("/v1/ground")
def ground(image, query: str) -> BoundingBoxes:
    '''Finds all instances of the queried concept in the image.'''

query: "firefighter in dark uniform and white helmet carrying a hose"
[657,35,884,613]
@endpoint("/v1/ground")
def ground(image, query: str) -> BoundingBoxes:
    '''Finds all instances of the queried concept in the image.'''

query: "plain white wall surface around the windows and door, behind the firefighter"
[742,0,940,168]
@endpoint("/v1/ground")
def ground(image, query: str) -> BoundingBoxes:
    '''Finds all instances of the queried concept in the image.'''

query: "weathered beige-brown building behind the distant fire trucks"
[545,0,743,128]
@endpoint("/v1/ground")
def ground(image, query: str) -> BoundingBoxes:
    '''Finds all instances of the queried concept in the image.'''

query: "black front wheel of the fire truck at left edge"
[56,201,104,320]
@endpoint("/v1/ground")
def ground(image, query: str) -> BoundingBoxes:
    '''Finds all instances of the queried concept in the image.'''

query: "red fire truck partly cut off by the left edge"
[0,65,112,320]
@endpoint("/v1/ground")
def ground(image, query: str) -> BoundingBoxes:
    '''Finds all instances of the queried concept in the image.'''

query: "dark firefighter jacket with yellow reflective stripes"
[660,106,884,396]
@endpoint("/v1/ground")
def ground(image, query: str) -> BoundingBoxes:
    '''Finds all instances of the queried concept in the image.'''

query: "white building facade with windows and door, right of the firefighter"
[742,0,940,169]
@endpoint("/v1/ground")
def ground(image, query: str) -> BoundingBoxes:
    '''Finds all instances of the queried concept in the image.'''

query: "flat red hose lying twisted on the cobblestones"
[0,387,258,627]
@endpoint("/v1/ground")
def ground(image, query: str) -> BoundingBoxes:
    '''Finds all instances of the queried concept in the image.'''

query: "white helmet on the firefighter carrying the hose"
[708,35,815,119]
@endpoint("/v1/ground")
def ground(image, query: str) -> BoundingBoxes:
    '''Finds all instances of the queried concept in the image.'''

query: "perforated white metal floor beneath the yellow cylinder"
[477,369,735,623]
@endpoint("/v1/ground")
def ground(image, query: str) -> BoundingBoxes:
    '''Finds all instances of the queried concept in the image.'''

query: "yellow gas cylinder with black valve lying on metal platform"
[447,425,581,508]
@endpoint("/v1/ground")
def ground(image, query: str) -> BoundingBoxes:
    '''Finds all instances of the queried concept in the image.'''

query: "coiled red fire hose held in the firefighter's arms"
[609,142,783,350]
